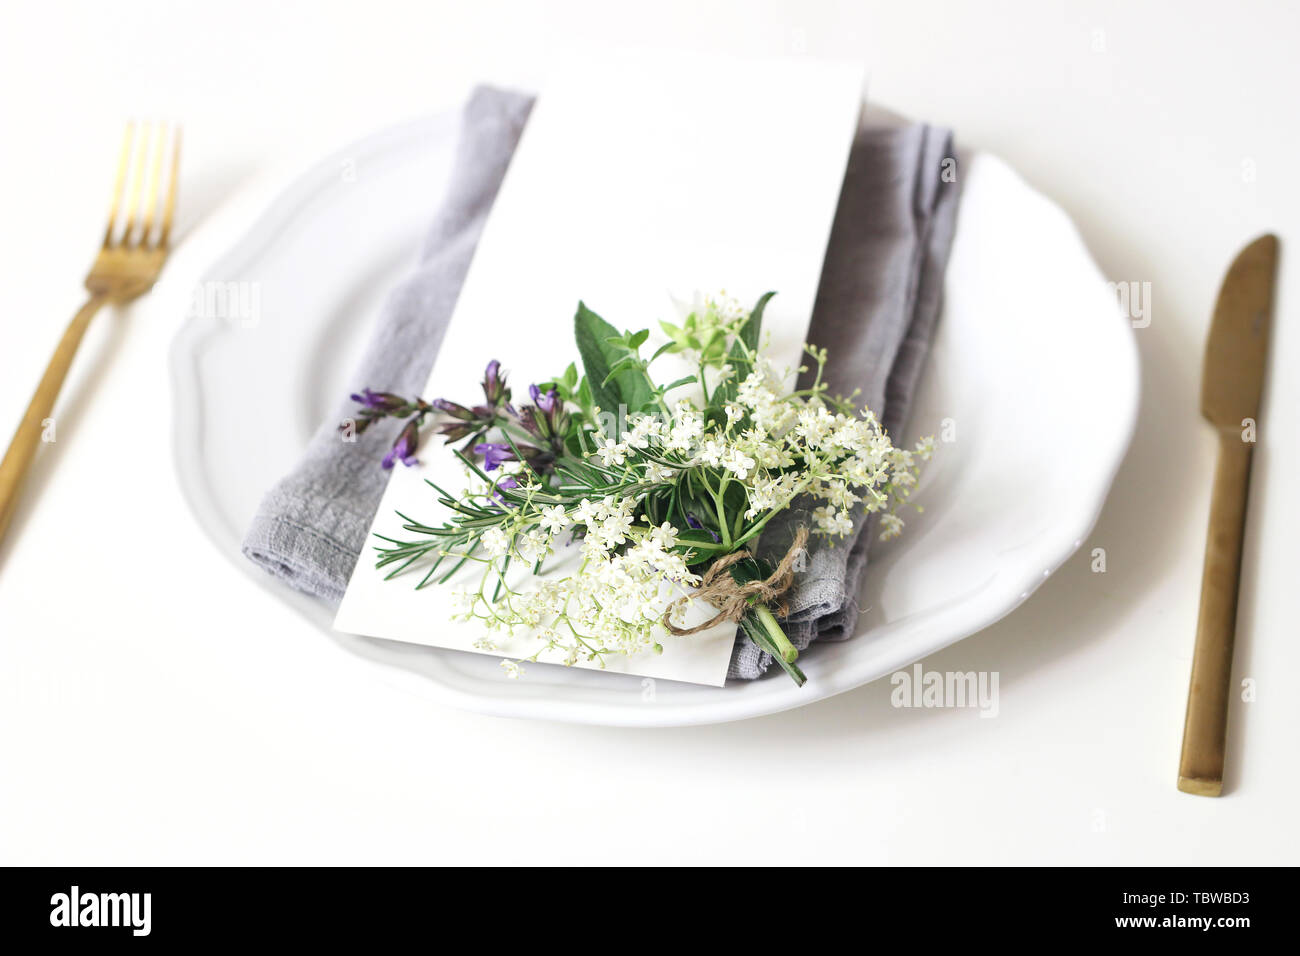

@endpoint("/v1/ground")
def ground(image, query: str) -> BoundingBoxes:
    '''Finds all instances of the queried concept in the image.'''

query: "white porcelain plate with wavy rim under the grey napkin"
[172,108,1139,726]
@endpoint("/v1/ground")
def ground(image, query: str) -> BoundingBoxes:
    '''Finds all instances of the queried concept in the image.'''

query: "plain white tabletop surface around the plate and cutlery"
[0,0,1300,864]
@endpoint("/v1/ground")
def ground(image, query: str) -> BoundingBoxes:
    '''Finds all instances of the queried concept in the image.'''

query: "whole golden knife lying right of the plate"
[1178,235,1278,796]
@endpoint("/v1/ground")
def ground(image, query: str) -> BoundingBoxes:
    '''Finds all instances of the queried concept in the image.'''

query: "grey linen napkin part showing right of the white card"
[728,122,958,680]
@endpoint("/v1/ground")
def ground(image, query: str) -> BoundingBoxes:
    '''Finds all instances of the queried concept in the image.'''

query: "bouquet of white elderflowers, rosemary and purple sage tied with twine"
[352,293,932,684]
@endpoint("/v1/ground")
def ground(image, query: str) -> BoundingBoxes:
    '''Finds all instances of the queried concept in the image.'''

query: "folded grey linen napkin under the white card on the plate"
[243,87,957,679]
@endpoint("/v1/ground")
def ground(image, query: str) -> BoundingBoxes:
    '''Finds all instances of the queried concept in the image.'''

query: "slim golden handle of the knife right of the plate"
[1178,428,1255,796]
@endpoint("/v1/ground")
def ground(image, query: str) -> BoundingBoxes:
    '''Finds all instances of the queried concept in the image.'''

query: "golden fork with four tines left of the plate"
[0,124,181,548]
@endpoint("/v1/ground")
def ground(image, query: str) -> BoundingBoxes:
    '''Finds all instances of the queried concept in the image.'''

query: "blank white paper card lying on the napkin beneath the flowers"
[334,55,863,685]
